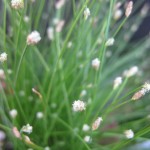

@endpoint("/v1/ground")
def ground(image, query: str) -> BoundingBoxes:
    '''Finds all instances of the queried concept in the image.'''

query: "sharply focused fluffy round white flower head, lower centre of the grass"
[72,100,86,111]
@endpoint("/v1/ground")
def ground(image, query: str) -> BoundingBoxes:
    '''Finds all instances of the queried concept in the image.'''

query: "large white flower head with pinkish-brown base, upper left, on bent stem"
[27,31,41,45]
